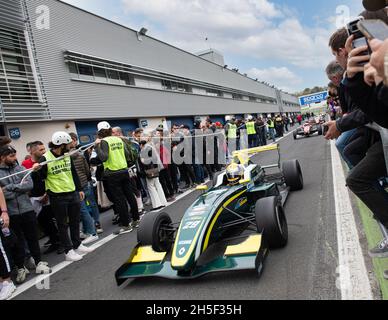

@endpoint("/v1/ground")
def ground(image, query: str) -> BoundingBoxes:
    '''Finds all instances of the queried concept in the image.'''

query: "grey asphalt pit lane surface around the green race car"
[15,131,341,300]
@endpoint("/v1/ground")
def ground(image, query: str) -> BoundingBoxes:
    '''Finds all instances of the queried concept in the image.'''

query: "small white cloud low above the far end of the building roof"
[247,67,303,92]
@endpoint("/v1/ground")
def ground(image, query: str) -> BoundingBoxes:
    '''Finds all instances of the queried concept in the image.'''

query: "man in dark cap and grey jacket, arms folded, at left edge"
[0,146,51,283]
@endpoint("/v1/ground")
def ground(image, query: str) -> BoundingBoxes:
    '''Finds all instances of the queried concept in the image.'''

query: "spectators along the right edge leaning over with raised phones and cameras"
[325,0,388,279]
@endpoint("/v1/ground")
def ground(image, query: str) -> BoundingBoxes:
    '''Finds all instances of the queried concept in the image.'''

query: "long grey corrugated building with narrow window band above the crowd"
[0,0,300,154]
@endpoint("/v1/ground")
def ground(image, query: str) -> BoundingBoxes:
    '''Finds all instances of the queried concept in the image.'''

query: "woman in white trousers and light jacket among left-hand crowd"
[139,135,167,210]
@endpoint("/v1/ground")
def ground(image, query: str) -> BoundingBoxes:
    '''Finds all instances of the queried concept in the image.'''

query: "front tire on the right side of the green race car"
[255,197,288,249]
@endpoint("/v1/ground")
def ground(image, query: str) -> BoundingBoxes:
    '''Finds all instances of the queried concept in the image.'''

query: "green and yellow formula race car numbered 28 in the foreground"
[115,145,303,286]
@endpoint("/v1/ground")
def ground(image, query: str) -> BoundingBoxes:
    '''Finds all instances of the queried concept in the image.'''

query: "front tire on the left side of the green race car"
[137,212,173,252]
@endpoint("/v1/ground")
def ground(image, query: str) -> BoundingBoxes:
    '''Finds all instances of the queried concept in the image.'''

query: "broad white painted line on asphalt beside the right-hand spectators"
[331,141,373,300]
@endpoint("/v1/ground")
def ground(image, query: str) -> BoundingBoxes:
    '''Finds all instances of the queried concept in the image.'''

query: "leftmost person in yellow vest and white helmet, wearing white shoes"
[33,132,93,261]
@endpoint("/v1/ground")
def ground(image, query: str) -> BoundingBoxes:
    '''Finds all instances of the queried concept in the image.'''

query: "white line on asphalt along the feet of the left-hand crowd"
[8,185,200,300]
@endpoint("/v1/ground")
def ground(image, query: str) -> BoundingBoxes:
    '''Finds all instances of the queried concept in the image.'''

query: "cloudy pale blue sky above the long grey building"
[59,0,363,93]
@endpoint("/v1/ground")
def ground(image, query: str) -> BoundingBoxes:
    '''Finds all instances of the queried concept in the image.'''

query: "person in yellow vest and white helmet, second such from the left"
[96,121,140,235]
